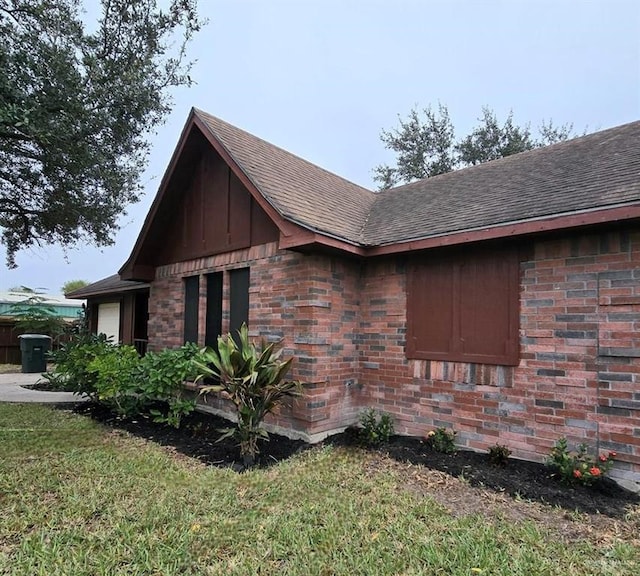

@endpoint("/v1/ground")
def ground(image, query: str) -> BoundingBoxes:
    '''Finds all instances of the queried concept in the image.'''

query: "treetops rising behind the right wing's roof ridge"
[374,104,575,189]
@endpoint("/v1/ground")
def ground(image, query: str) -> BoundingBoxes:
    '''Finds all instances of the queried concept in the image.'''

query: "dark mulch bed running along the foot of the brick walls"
[67,403,640,518]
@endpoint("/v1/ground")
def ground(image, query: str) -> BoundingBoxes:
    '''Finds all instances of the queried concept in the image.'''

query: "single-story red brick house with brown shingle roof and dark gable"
[70,110,640,481]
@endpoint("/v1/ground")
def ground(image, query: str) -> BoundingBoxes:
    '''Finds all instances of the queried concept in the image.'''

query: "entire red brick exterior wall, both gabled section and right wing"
[149,228,640,481]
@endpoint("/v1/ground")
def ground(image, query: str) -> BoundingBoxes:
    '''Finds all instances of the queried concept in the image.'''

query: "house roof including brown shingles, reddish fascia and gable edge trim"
[120,109,640,280]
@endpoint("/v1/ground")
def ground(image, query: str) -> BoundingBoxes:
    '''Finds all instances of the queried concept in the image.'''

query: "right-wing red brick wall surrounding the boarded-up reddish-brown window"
[360,229,640,479]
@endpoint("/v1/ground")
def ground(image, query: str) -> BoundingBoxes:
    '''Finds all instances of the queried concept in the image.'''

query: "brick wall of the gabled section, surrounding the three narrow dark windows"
[149,243,362,438]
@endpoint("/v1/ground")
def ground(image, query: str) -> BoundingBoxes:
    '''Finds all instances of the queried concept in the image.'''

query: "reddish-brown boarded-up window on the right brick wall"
[407,249,519,365]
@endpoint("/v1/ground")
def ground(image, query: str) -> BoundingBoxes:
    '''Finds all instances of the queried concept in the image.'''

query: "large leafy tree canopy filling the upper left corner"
[0,0,202,267]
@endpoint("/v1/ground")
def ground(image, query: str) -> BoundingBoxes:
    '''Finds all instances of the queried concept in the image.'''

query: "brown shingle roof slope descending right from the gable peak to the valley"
[195,110,377,244]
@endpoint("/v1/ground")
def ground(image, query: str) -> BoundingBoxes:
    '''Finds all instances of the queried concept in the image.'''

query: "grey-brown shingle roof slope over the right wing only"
[363,122,640,246]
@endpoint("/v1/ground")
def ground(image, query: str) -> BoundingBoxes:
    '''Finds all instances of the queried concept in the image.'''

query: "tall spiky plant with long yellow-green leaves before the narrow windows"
[197,324,301,467]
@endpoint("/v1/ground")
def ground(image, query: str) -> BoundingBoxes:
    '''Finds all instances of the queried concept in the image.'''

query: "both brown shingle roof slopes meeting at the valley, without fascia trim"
[195,110,640,246]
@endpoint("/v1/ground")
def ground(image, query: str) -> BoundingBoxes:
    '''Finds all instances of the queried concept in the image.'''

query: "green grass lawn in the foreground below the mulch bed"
[0,404,640,576]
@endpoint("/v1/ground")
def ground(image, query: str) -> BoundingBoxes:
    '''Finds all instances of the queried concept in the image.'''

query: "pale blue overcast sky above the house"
[0,0,640,294]
